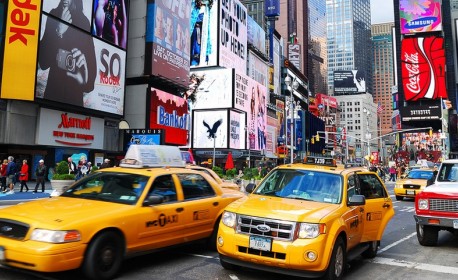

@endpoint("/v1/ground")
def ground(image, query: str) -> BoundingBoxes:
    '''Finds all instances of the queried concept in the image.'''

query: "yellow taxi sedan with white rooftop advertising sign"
[0,145,244,279]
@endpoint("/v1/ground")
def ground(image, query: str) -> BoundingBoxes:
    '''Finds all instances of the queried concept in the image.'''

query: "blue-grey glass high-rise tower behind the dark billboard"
[326,0,373,95]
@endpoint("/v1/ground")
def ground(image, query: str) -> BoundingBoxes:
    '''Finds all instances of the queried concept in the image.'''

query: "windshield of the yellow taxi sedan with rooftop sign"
[61,172,149,205]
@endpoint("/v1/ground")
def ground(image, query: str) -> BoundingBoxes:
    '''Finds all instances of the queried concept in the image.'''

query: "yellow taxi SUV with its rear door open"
[217,157,394,279]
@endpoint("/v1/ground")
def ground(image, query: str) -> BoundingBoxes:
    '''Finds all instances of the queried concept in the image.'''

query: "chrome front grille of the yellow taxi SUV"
[237,215,296,241]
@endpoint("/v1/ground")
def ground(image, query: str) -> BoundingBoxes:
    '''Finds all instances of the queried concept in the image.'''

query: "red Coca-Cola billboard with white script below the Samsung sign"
[401,37,448,101]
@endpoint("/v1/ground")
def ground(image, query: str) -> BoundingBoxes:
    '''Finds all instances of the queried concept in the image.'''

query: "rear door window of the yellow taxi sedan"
[178,174,215,200]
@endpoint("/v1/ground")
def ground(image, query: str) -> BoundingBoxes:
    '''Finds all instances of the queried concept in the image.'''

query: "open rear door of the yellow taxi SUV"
[358,173,394,242]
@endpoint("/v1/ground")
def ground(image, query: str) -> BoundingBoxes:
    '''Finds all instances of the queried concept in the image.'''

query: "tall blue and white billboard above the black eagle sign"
[190,0,220,68]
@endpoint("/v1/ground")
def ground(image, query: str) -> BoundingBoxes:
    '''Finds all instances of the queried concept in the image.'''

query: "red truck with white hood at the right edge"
[414,159,458,246]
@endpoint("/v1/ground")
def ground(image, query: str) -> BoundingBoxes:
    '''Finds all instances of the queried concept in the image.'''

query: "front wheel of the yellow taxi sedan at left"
[82,232,123,280]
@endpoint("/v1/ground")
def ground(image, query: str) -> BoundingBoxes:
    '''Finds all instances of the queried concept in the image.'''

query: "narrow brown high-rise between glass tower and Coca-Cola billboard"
[371,22,394,135]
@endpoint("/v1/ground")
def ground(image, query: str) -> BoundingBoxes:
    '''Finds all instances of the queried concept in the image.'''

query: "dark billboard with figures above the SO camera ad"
[92,0,129,49]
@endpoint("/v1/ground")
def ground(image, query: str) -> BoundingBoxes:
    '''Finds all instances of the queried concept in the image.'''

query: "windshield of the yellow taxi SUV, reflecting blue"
[254,169,342,204]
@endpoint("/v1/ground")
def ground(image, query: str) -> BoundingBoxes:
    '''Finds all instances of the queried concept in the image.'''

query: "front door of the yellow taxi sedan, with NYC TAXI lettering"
[137,175,185,250]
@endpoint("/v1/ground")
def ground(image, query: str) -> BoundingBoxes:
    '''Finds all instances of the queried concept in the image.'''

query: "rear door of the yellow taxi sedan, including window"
[177,173,223,240]
